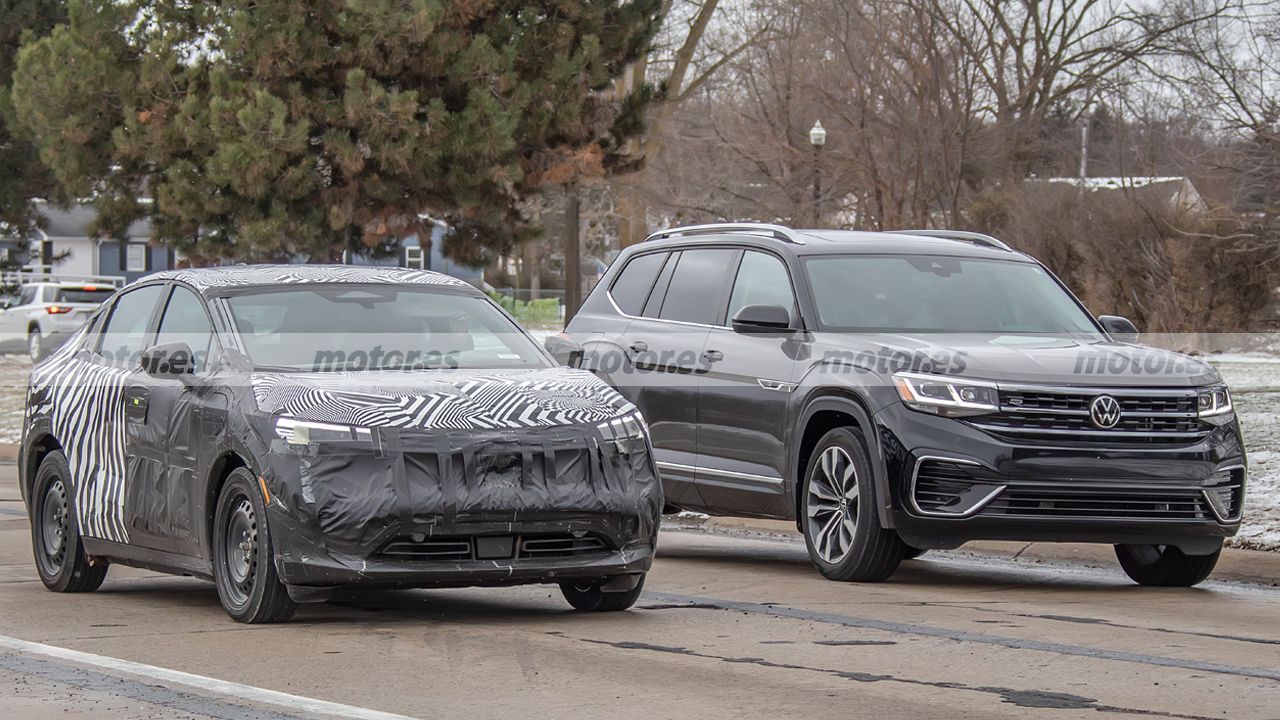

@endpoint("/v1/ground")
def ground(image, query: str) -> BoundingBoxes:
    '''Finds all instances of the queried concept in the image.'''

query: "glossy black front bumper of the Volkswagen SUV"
[876,404,1245,553]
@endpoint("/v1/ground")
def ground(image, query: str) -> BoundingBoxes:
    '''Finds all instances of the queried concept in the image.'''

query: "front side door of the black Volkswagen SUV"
[698,250,804,516]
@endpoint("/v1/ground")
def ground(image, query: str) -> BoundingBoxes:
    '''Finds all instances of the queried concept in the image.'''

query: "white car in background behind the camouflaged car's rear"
[0,275,124,363]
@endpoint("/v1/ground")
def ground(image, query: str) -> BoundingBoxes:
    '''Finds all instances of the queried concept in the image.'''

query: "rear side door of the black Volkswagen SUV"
[622,247,739,509]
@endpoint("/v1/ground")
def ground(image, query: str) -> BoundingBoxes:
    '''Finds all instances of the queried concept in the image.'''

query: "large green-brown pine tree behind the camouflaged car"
[13,0,660,261]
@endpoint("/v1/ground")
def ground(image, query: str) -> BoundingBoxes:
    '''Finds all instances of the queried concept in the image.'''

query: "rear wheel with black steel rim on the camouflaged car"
[31,450,108,592]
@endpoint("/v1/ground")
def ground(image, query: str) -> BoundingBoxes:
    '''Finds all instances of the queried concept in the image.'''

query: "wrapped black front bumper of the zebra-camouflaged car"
[256,417,663,601]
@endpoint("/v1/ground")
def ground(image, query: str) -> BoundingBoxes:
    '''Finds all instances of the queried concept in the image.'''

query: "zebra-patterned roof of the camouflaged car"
[142,265,479,292]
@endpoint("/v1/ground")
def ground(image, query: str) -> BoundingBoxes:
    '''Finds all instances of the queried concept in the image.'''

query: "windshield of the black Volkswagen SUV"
[805,255,1101,337]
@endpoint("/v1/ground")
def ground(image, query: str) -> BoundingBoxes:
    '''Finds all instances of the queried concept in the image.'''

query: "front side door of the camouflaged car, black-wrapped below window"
[135,284,216,556]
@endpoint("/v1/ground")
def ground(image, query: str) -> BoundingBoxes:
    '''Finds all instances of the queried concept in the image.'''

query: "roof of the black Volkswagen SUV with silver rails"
[637,229,1033,263]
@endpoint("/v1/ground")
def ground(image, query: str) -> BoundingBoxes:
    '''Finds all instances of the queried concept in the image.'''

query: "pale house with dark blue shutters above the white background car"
[31,201,175,281]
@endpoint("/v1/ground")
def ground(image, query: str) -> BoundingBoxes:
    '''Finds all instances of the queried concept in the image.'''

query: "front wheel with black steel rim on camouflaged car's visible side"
[214,468,297,623]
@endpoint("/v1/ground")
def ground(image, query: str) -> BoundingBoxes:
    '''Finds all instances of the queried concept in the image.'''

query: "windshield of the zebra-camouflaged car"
[228,283,548,372]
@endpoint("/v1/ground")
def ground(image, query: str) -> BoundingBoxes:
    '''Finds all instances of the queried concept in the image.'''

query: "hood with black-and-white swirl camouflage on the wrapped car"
[250,368,635,429]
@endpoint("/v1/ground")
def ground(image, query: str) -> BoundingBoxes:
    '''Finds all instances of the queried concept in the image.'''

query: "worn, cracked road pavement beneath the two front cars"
[0,466,1280,720]
